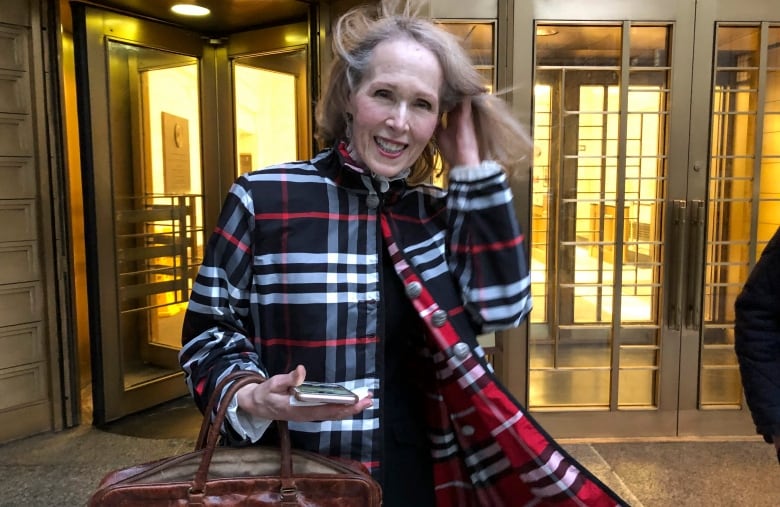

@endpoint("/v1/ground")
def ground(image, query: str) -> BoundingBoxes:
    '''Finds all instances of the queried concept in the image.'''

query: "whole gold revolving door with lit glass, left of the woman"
[73,3,312,424]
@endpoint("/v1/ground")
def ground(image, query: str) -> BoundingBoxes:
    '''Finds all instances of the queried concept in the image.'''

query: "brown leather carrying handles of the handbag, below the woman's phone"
[188,370,297,505]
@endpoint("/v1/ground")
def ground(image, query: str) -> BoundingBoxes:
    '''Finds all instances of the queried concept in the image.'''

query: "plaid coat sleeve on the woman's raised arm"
[447,161,532,333]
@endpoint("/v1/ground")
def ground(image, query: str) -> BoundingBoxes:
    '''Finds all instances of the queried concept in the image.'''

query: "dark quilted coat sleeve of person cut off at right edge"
[734,229,780,442]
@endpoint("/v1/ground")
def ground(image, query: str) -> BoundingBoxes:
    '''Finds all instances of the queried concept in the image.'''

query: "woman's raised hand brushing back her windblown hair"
[436,97,482,167]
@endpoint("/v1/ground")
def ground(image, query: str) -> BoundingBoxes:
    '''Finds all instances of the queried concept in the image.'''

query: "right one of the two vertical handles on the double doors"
[685,200,706,330]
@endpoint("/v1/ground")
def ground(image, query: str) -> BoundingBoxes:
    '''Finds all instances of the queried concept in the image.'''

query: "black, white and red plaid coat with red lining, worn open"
[180,146,620,507]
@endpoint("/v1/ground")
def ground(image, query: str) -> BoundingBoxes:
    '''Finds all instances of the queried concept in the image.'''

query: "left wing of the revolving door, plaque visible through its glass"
[73,4,208,424]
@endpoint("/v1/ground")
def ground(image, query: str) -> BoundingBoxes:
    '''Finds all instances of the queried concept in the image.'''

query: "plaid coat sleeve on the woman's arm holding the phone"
[179,179,265,411]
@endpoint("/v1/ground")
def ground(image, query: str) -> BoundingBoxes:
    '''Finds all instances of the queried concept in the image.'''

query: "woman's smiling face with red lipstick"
[347,39,442,177]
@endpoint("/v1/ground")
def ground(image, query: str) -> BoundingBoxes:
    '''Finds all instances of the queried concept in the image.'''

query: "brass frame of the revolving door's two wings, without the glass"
[72,2,313,424]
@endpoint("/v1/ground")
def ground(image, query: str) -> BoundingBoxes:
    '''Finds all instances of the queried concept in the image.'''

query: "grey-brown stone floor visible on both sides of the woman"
[0,398,780,507]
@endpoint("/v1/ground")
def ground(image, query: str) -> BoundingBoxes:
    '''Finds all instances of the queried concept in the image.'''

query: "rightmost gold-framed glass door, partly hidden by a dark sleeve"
[670,0,780,435]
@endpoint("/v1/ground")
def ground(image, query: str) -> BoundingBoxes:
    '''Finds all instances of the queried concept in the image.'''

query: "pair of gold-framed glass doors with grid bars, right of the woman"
[502,0,780,437]
